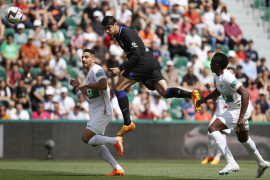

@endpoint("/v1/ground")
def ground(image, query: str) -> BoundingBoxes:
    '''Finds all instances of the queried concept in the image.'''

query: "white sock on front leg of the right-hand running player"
[211,131,236,164]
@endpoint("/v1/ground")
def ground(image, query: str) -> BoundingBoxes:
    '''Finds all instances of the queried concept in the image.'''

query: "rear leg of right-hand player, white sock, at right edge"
[236,130,270,178]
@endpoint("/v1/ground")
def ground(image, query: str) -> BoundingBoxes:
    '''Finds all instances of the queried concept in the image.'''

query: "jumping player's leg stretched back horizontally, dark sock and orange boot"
[154,79,201,112]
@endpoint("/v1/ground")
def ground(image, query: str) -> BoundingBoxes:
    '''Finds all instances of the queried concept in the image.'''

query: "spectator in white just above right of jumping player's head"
[115,3,132,27]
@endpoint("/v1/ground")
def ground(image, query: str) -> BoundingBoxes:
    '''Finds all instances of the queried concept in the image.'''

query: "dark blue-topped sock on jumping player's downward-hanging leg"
[115,91,131,126]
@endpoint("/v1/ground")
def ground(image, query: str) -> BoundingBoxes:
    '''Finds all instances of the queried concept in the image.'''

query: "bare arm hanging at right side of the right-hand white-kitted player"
[237,85,249,133]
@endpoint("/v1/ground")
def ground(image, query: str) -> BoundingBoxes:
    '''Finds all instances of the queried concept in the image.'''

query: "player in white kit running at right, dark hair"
[197,53,270,178]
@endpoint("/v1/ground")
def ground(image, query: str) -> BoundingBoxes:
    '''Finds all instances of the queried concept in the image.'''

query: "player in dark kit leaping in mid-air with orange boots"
[102,16,201,136]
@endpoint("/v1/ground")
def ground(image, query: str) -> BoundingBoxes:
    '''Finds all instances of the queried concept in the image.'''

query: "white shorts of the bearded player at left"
[86,113,112,135]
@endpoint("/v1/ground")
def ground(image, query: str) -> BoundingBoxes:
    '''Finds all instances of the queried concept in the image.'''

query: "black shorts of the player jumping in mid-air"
[122,58,164,90]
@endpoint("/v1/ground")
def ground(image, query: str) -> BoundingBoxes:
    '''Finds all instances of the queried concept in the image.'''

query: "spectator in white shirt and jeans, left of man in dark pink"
[208,14,229,51]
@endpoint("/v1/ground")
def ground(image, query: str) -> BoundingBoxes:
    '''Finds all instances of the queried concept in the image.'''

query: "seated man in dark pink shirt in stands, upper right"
[224,16,246,50]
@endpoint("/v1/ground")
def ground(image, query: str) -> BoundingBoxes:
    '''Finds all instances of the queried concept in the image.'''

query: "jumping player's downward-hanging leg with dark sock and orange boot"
[115,76,137,136]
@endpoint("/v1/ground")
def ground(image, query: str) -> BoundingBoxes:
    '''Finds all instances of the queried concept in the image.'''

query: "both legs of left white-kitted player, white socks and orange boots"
[82,129,124,176]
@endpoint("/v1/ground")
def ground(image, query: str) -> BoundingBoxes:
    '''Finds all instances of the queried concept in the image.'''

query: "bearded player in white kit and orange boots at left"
[70,49,124,176]
